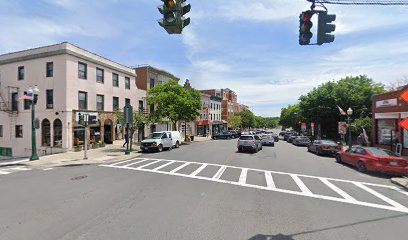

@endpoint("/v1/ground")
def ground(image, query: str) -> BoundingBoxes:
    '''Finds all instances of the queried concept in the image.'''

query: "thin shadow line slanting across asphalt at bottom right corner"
[248,213,408,240]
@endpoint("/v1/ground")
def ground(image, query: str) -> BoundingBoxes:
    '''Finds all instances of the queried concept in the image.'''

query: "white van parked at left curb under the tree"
[140,131,182,152]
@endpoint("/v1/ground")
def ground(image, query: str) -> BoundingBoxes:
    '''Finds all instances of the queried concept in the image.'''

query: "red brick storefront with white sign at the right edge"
[371,88,408,155]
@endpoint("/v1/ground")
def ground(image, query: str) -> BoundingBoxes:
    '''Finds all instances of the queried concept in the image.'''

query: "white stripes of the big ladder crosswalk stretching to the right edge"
[100,158,408,213]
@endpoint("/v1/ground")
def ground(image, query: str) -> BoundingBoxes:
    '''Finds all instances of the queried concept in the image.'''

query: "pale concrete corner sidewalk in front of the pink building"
[25,140,140,168]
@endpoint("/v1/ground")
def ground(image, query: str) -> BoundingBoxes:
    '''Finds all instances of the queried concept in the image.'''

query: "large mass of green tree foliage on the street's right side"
[281,75,386,138]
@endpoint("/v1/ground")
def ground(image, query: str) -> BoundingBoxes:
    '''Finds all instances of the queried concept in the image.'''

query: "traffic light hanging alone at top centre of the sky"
[158,0,191,34]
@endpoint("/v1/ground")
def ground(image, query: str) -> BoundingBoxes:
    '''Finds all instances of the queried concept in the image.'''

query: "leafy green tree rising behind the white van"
[147,80,201,131]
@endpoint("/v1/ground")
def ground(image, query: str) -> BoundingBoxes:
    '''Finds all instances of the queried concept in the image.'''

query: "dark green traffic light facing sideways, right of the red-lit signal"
[317,11,336,45]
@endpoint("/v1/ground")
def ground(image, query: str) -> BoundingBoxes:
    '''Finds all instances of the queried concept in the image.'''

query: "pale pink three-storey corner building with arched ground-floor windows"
[0,42,146,157]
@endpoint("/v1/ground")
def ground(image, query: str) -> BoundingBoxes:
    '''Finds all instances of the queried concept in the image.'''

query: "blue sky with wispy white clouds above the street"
[0,0,408,117]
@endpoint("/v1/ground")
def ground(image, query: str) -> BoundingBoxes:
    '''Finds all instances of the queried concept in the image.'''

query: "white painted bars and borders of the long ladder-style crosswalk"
[99,158,408,213]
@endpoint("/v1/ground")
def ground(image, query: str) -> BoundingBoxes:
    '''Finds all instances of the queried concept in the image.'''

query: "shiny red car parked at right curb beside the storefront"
[336,146,408,175]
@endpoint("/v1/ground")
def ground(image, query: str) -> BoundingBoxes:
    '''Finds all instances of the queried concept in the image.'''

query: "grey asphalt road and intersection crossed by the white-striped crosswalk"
[0,140,408,240]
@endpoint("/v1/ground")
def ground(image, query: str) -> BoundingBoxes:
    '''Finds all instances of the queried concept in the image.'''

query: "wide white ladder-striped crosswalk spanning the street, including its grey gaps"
[99,158,408,213]
